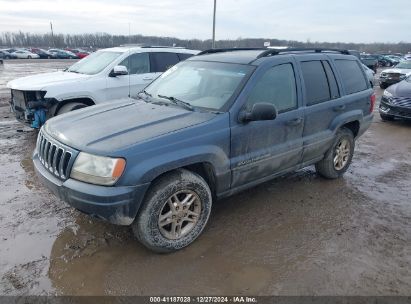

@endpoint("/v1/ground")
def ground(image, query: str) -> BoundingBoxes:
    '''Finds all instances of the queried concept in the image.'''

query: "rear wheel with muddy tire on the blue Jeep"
[315,128,355,179]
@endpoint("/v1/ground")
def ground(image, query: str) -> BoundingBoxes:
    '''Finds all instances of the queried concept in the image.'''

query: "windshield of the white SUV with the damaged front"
[67,51,123,75]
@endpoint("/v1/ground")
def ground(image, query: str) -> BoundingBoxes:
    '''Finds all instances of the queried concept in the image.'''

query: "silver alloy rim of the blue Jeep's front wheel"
[158,190,201,240]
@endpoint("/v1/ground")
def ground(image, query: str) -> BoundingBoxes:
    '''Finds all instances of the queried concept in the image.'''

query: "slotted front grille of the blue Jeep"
[37,131,75,180]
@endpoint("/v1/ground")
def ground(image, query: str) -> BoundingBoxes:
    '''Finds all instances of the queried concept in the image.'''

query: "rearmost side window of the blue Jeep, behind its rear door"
[335,59,368,94]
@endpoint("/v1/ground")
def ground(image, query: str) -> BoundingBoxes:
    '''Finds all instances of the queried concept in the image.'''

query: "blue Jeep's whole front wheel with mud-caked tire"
[132,169,212,252]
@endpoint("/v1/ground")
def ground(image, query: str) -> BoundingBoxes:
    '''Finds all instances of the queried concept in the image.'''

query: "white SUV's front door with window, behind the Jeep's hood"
[106,53,154,99]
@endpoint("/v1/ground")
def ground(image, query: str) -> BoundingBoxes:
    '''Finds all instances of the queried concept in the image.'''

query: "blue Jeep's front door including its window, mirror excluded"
[231,57,304,188]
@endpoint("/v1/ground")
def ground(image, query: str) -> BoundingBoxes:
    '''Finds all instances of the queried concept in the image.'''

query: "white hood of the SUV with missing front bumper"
[7,71,91,91]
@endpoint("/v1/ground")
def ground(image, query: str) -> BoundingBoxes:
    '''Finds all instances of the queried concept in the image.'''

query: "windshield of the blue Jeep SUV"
[145,61,253,110]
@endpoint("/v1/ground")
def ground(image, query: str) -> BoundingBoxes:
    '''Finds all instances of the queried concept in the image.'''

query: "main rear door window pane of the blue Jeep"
[301,60,331,105]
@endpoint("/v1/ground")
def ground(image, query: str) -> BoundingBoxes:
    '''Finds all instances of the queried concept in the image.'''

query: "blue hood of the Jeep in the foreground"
[44,99,216,155]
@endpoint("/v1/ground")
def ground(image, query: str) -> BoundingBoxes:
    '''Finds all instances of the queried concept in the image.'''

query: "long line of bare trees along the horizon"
[0,31,411,54]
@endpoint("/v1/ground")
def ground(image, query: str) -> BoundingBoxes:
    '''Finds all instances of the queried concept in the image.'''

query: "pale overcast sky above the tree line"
[0,0,411,42]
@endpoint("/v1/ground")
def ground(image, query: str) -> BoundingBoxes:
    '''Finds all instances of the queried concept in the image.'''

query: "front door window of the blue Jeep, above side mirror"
[247,63,297,113]
